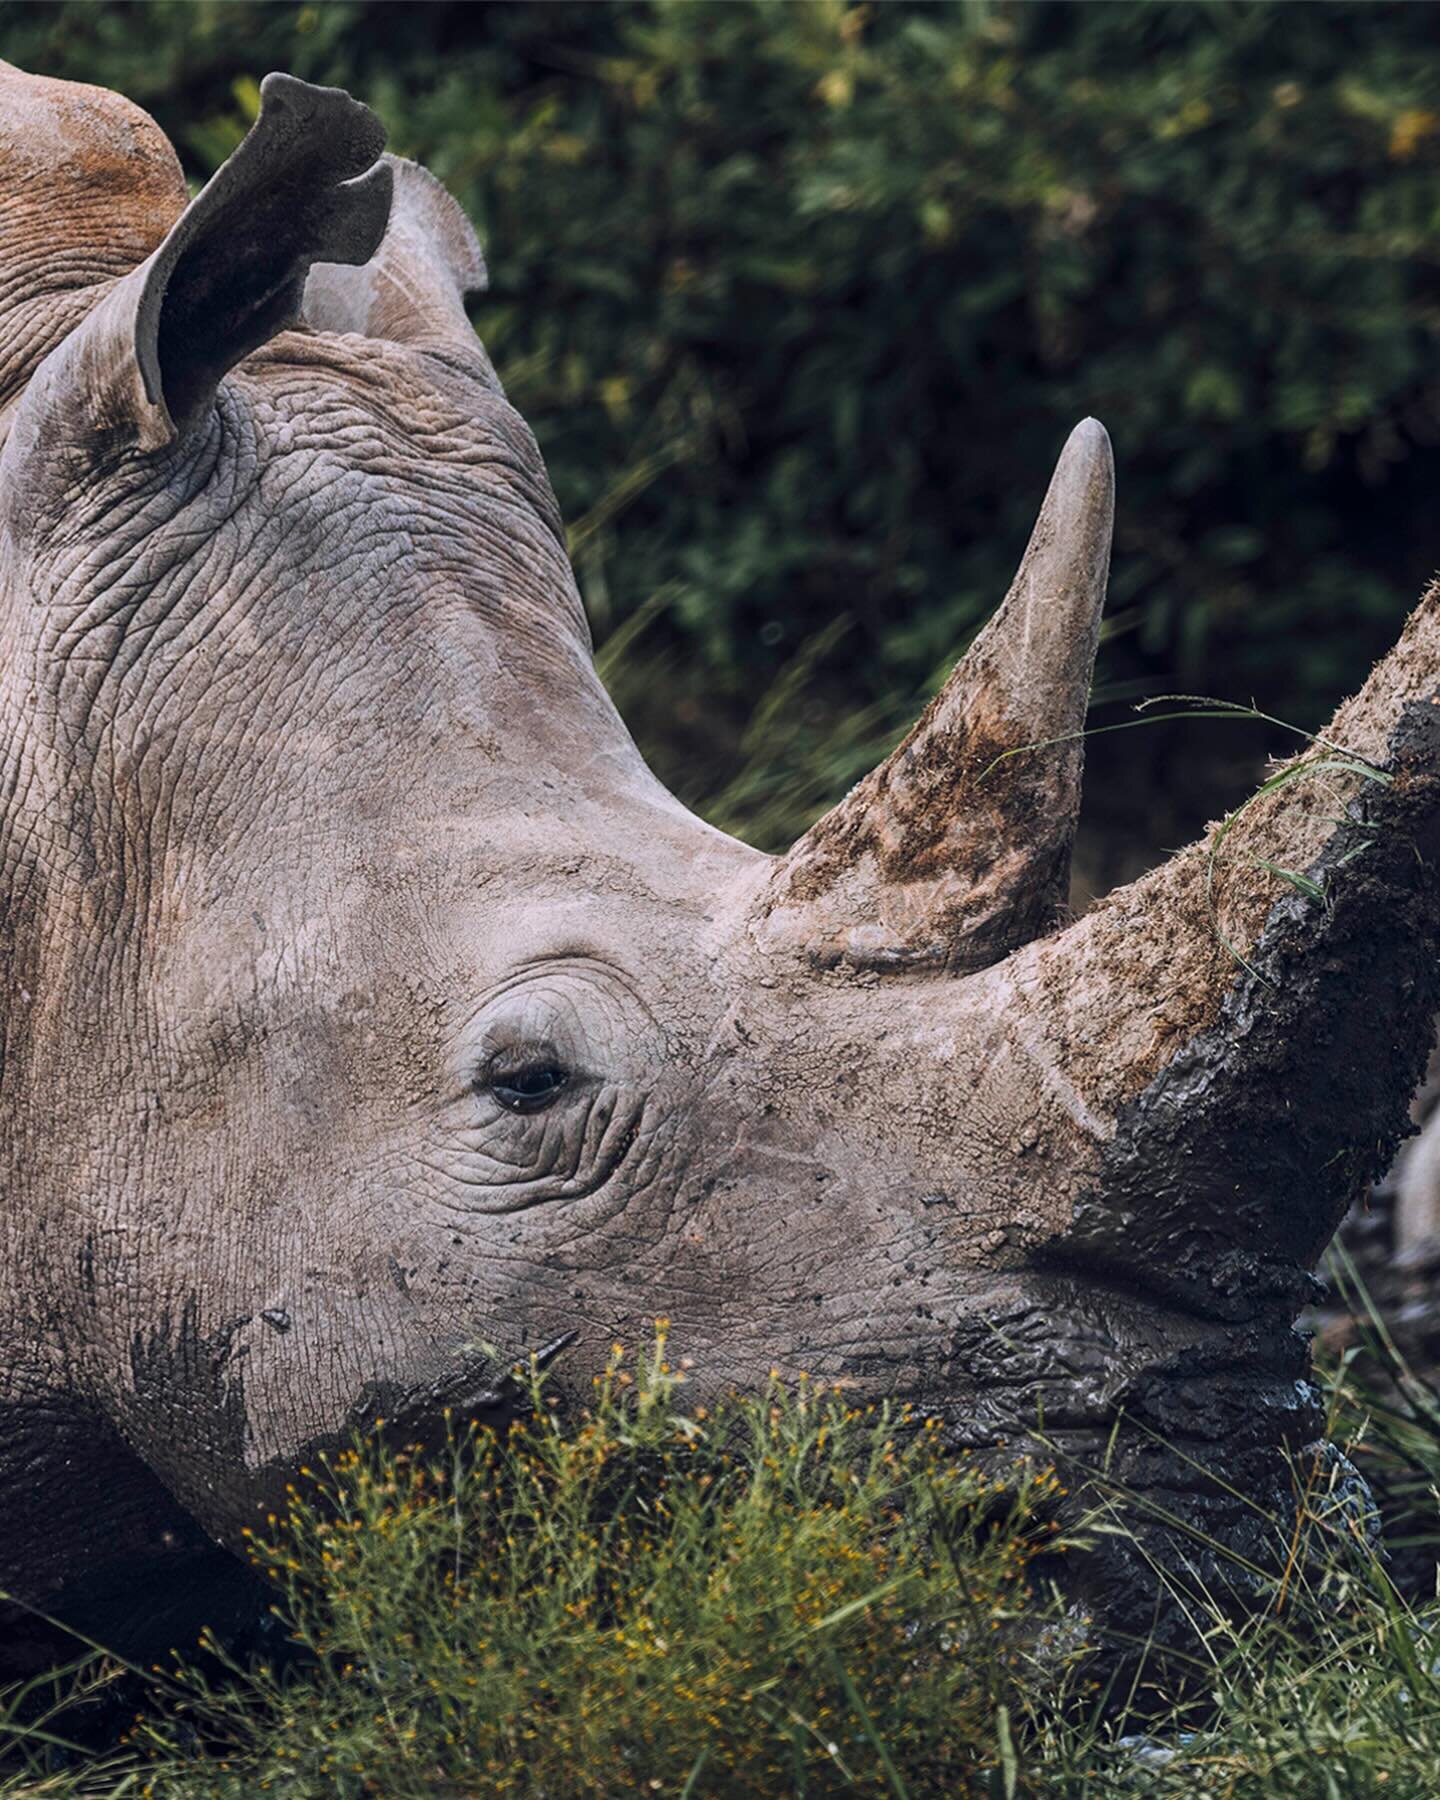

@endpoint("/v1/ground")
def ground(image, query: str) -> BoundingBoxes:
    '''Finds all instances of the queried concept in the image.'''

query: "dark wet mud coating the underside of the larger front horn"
[1057,695,1440,1321]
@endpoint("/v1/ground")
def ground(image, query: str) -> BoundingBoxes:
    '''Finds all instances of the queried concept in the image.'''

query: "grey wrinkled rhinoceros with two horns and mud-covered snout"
[0,67,1440,1663]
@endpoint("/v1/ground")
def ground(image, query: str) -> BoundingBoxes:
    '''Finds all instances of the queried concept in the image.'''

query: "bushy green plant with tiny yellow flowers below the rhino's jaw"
[19,1325,1064,1800]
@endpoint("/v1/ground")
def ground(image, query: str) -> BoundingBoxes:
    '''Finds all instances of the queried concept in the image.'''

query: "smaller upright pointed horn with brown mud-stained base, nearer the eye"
[758,419,1114,972]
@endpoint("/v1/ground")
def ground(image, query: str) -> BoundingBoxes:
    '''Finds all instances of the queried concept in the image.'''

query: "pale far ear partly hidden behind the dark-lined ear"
[304,157,499,385]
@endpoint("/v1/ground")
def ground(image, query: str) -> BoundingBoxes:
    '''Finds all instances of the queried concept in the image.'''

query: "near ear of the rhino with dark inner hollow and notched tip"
[126,74,392,448]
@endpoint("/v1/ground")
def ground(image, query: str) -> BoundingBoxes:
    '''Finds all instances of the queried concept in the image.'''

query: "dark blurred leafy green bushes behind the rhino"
[0,0,1440,900]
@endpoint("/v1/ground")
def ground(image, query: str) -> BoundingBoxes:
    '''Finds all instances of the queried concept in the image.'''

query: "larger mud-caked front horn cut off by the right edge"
[993,585,1440,1319]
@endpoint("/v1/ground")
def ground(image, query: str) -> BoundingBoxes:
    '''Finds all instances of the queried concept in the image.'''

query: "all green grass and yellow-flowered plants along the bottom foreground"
[0,1327,1440,1800]
